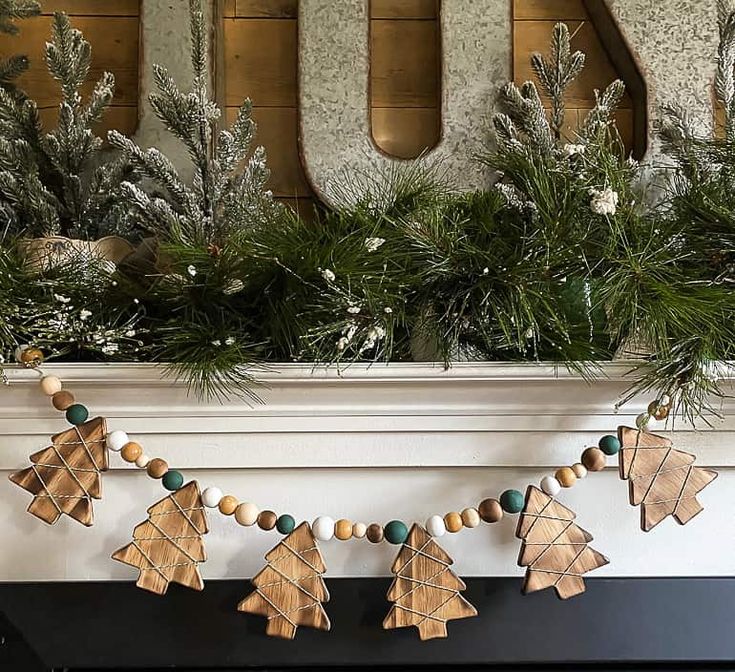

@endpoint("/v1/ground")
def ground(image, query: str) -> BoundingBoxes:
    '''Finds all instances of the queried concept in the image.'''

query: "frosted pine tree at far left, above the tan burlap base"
[0,13,137,238]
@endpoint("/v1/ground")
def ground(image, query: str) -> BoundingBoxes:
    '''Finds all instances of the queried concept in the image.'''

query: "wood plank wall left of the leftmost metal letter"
[0,0,140,135]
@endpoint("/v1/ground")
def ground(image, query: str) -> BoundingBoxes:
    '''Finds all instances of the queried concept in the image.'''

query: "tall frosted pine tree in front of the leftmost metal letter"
[109,0,278,248]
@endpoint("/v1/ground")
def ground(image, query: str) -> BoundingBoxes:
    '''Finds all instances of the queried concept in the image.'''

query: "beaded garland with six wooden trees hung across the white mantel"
[10,348,717,640]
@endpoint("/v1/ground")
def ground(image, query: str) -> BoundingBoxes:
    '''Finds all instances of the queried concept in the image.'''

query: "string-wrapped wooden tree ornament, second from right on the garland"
[516,485,609,600]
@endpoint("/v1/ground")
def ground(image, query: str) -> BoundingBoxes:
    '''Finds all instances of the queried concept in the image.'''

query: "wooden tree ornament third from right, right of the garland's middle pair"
[383,524,477,640]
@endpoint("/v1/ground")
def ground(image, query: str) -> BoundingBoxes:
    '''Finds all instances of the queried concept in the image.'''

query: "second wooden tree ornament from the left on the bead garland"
[112,481,209,595]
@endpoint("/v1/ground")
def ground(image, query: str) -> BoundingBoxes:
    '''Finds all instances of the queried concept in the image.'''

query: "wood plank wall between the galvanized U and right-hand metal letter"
[513,0,645,150]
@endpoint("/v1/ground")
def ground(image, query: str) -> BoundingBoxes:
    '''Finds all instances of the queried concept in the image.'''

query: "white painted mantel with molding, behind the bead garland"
[0,363,735,581]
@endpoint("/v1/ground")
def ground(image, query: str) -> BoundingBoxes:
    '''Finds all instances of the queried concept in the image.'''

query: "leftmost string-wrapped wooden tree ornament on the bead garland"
[10,418,108,527]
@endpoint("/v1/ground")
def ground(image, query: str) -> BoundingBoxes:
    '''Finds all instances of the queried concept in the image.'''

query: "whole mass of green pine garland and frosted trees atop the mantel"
[0,0,735,420]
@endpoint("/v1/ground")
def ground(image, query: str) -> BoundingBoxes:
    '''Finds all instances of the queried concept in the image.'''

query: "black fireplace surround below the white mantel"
[0,578,735,672]
